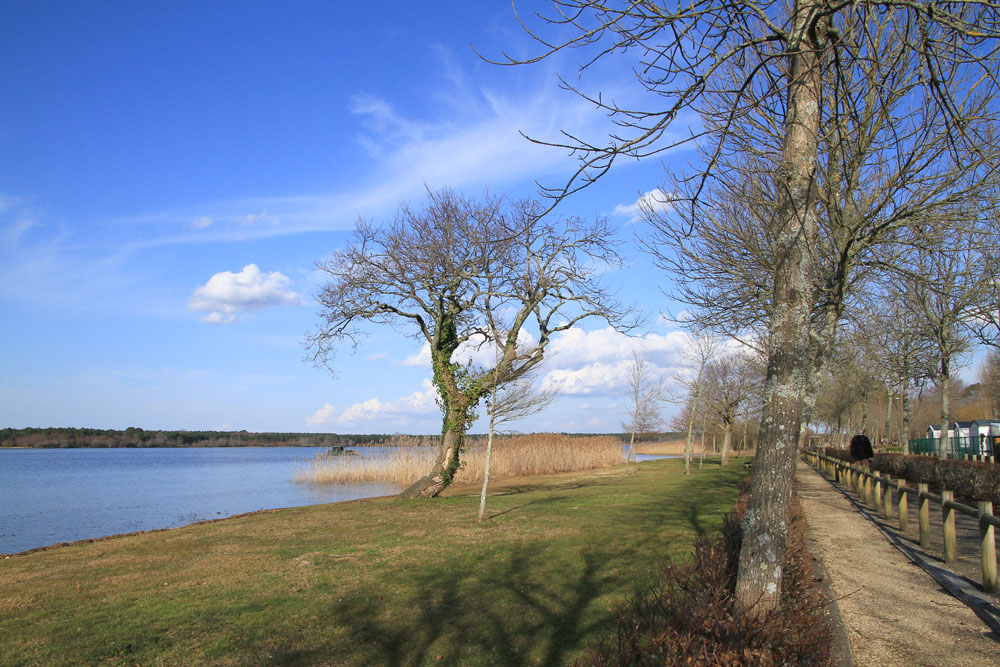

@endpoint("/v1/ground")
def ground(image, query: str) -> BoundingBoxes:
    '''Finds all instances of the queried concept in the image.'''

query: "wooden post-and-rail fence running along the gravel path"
[803,451,1000,593]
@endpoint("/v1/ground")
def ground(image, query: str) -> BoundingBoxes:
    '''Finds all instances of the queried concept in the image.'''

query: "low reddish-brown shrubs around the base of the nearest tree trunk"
[581,497,831,666]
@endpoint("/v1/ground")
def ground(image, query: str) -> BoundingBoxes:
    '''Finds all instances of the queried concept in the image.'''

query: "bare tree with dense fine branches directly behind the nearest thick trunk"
[641,13,1000,454]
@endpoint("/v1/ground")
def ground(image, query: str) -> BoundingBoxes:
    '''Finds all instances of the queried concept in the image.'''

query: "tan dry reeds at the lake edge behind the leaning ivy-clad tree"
[295,433,625,487]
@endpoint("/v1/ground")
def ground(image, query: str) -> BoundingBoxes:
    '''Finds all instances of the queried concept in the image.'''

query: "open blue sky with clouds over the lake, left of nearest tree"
[0,0,704,433]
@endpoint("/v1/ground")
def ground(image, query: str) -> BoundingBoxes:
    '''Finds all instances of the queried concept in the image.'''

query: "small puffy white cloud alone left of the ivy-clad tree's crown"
[188,264,302,324]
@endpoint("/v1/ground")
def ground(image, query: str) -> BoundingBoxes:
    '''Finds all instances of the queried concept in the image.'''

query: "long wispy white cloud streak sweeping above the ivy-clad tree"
[111,58,640,248]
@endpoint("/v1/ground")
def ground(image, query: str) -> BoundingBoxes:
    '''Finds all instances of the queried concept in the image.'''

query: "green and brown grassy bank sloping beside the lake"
[0,460,745,665]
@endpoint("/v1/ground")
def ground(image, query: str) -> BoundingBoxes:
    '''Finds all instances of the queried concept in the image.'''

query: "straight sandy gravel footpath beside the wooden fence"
[796,462,1000,667]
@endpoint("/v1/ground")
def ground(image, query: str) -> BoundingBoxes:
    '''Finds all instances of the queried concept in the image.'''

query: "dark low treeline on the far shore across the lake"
[0,427,390,448]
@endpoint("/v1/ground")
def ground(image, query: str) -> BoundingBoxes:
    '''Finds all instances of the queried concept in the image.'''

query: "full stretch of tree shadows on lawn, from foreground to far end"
[274,468,748,665]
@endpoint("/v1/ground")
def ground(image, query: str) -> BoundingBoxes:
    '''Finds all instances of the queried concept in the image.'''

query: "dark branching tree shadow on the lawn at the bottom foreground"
[274,544,621,665]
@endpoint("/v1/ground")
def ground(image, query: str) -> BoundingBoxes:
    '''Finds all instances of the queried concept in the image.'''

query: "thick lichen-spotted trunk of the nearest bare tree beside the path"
[736,0,820,614]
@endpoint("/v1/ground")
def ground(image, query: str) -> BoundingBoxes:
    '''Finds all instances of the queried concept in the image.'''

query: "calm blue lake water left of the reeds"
[0,447,398,553]
